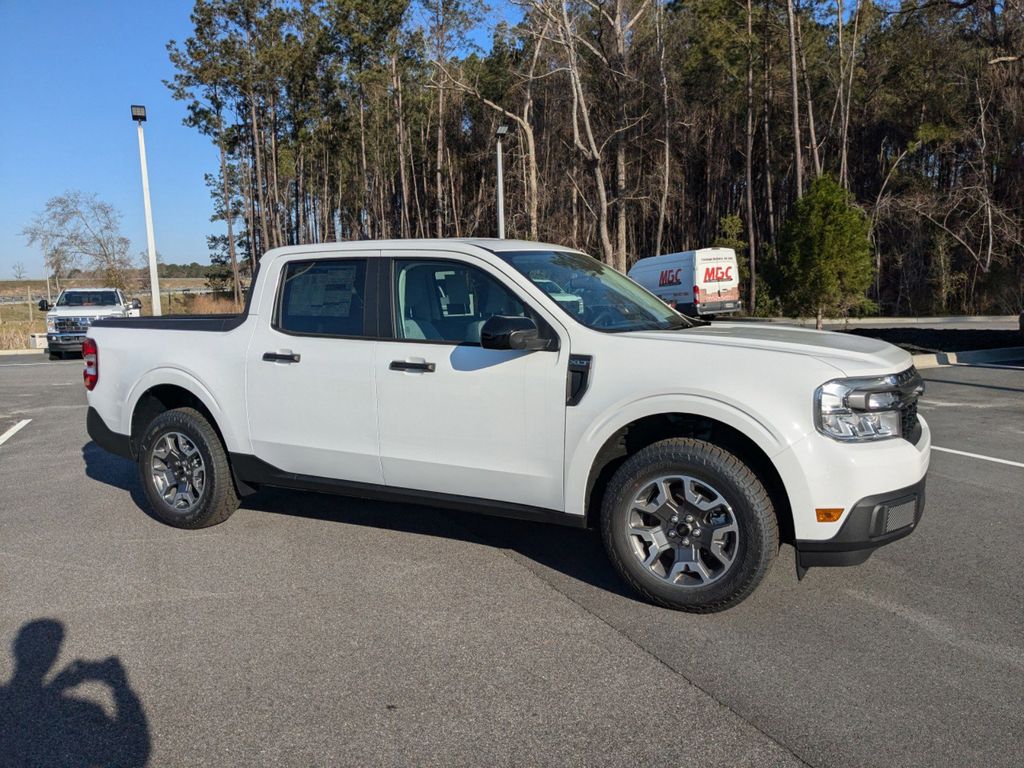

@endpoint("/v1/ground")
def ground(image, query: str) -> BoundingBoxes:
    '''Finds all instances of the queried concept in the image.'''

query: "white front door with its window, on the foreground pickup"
[374,253,568,510]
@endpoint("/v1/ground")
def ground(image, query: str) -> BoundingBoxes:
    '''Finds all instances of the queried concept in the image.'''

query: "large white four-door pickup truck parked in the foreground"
[84,240,931,611]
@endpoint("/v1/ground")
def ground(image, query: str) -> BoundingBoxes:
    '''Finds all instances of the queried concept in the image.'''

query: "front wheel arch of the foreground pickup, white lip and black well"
[566,409,794,542]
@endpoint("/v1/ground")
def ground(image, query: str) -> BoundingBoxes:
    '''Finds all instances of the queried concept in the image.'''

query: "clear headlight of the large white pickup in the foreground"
[814,376,902,442]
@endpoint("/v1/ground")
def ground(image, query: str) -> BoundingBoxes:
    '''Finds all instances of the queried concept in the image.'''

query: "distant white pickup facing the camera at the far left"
[39,288,142,360]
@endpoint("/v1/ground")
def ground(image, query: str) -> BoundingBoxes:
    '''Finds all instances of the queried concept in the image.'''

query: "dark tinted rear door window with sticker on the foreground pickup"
[274,259,367,336]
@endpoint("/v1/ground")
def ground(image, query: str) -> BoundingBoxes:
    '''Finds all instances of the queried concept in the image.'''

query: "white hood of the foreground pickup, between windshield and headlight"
[623,323,912,376]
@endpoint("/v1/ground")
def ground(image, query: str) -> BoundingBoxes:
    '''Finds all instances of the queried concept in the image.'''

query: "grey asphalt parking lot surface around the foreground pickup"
[0,355,1024,766]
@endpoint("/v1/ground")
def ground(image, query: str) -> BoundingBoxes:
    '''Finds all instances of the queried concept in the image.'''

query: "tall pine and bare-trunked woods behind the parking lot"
[24,0,1024,314]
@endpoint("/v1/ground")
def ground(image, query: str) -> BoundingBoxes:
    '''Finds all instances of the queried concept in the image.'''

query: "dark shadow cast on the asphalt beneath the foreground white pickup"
[82,442,635,599]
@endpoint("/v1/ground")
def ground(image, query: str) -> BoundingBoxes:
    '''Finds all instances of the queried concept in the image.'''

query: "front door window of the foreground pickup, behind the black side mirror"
[394,259,527,344]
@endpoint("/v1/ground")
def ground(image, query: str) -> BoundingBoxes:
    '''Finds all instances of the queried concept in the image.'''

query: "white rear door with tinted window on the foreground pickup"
[246,251,383,484]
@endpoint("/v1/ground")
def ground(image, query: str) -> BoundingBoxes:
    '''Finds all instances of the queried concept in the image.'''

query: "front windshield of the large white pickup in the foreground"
[498,251,692,333]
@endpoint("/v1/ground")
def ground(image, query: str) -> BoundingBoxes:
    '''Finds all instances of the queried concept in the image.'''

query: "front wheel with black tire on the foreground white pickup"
[601,438,778,613]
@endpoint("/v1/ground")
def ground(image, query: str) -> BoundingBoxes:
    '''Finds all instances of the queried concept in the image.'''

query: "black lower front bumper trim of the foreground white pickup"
[794,477,926,575]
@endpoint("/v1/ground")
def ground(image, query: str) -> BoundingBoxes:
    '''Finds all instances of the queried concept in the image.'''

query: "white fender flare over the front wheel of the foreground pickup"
[565,394,790,515]
